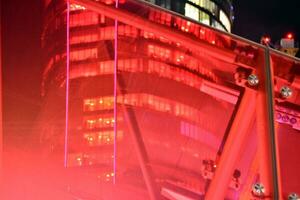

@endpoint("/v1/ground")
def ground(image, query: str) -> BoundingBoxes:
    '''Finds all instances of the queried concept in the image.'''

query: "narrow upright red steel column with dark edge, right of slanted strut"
[257,47,280,200]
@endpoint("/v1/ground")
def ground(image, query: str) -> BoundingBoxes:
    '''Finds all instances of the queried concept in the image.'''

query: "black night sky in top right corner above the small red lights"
[233,0,300,42]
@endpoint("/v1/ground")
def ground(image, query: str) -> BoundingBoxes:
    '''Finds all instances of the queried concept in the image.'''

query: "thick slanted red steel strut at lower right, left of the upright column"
[205,88,256,200]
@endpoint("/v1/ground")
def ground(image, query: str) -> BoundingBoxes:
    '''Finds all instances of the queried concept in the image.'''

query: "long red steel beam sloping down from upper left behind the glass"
[72,0,236,63]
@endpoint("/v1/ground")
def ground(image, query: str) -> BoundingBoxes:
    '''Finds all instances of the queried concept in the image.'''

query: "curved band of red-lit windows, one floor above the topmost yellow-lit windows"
[70,59,217,94]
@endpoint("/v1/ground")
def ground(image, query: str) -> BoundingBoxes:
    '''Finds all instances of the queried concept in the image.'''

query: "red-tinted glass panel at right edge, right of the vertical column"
[271,52,300,199]
